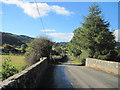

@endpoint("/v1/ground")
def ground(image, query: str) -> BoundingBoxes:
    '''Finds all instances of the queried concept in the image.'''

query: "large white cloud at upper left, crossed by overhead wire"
[1,0,73,18]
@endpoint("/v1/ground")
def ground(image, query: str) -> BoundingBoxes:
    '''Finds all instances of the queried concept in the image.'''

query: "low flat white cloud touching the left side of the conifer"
[45,33,73,40]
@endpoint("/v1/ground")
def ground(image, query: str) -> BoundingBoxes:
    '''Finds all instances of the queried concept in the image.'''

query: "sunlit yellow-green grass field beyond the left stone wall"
[0,55,26,71]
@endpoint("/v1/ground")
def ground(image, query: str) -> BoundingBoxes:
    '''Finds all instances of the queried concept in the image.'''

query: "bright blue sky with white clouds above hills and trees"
[0,0,118,42]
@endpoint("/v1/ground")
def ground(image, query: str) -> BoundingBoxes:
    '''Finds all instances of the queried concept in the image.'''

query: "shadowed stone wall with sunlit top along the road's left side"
[0,58,48,89]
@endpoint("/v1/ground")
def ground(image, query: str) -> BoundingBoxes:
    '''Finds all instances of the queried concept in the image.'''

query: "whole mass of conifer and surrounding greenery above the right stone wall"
[66,3,120,62]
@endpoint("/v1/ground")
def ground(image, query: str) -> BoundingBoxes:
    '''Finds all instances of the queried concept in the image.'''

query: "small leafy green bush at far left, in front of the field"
[2,58,18,80]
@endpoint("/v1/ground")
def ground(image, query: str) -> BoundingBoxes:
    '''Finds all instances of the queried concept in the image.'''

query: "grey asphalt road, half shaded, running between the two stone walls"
[41,56,118,89]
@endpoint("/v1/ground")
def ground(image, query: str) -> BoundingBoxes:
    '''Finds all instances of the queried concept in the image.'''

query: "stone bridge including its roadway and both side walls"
[0,57,120,90]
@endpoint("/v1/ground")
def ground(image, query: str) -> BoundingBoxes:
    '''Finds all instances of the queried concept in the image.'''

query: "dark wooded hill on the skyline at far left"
[0,32,34,46]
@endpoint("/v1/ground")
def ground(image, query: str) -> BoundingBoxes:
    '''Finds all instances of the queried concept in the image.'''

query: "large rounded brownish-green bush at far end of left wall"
[25,37,52,65]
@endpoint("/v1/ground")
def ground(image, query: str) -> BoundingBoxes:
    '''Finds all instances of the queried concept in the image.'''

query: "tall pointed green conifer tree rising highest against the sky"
[67,3,116,59]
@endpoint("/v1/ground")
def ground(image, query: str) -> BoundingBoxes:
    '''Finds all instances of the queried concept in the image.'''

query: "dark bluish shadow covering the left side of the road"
[38,58,73,89]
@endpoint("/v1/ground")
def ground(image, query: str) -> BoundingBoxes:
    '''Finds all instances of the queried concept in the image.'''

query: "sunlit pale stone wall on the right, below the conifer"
[86,58,120,74]
